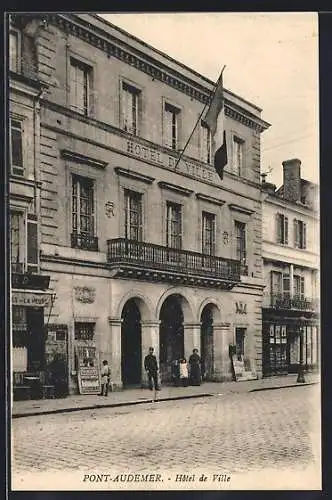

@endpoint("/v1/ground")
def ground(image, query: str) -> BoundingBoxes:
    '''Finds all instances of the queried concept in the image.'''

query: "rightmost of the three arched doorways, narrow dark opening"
[201,304,216,380]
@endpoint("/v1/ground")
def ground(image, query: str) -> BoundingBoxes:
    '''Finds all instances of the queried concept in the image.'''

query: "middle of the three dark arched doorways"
[159,294,184,382]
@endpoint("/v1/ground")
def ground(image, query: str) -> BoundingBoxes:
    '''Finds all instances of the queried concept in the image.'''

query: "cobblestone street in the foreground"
[12,387,319,489]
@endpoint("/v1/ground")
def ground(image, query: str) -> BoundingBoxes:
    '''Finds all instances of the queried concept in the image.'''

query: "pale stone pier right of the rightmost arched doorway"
[213,323,232,381]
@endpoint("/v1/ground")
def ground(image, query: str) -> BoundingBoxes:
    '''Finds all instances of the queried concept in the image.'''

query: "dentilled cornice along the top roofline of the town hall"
[14,14,270,133]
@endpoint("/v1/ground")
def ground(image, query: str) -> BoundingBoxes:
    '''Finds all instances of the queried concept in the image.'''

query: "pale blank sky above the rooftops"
[101,12,319,186]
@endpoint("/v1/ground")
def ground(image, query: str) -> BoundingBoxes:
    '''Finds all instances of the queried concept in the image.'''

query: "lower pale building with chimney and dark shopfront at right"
[262,159,320,376]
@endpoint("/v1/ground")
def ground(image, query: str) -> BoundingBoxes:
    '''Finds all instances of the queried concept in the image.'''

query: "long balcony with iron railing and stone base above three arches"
[107,238,240,290]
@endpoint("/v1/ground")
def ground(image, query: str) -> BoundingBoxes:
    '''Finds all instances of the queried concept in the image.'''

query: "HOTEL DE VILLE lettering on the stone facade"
[126,141,215,183]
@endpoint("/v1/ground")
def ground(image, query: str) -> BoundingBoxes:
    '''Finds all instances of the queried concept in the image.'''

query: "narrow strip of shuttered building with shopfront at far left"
[7,16,52,382]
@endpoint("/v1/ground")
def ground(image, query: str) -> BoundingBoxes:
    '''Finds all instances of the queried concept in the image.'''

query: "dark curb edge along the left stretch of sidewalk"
[12,393,213,418]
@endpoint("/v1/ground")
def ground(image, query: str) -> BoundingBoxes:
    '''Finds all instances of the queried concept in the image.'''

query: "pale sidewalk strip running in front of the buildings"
[12,373,320,418]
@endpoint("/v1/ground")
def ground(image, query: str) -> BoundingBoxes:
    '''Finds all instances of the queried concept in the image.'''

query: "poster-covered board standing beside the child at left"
[76,343,101,394]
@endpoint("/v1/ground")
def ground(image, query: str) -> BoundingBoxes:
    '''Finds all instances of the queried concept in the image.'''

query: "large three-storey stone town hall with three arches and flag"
[9,14,269,393]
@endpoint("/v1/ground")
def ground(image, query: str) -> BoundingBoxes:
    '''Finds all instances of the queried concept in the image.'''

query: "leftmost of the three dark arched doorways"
[121,299,142,387]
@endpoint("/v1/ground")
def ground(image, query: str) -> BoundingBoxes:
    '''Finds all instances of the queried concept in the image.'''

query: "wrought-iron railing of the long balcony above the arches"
[107,238,240,282]
